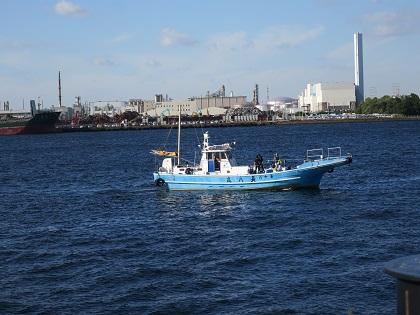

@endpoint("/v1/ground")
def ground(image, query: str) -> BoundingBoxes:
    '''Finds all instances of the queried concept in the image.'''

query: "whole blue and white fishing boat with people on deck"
[151,107,352,191]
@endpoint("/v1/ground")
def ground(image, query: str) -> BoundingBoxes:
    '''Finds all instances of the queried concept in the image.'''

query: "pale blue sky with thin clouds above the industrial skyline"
[0,0,420,109]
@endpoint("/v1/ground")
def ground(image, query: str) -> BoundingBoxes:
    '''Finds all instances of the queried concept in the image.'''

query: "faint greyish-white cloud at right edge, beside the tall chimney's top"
[364,10,420,37]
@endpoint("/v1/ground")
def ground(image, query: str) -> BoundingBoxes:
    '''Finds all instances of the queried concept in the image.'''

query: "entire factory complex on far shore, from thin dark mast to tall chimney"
[1,33,364,123]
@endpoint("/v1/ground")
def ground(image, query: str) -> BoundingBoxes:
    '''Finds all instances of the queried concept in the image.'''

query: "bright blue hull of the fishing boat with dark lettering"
[153,157,351,191]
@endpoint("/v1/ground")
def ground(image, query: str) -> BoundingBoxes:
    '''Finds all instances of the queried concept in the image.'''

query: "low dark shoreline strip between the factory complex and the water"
[55,116,420,133]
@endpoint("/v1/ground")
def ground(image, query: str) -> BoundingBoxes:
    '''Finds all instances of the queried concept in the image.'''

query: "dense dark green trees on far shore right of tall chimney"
[357,93,420,116]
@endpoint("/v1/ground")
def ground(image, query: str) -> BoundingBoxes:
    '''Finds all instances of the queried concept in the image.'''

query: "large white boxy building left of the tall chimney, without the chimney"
[298,83,356,113]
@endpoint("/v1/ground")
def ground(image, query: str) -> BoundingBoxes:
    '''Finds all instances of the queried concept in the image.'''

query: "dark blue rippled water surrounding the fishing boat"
[0,122,420,314]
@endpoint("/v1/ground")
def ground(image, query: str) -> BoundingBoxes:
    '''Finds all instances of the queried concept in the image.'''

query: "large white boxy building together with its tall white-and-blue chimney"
[298,33,364,113]
